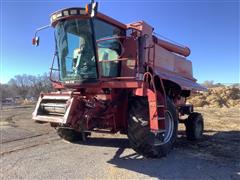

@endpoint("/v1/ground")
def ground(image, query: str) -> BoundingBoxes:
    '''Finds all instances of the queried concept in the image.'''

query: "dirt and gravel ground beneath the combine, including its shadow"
[0,106,240,179]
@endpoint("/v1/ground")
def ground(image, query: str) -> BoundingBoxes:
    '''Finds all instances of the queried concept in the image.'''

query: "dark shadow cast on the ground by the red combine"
[76,131,240,179]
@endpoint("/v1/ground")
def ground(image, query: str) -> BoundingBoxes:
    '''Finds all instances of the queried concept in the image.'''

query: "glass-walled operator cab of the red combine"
[51,8,125,83]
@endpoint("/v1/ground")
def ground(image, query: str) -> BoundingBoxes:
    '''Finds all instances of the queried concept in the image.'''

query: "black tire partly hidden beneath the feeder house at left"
[57,127,90,142]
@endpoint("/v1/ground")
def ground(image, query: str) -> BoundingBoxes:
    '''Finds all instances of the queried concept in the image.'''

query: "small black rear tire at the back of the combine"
[185,112,204,141]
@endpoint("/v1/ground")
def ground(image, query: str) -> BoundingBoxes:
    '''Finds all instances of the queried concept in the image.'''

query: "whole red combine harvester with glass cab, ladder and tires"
[33,2,205,157]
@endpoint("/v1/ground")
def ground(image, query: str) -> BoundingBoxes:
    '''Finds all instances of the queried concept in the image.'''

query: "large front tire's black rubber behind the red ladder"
[127,97,178,158]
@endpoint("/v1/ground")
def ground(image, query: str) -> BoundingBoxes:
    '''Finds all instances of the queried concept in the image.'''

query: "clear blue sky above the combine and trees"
[0,0,240,83]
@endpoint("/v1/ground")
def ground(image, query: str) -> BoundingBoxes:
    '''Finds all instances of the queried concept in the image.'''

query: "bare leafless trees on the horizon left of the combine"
[0,73,53,99]
